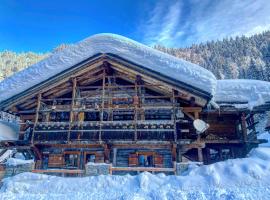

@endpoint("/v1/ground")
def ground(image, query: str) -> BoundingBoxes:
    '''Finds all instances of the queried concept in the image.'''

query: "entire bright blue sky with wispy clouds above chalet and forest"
[0,0,270,52]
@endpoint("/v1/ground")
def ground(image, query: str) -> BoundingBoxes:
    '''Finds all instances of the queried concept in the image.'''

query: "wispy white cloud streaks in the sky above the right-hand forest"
[140,0,270,46]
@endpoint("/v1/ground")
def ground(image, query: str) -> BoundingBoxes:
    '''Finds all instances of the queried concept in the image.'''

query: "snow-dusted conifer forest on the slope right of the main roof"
[155,31,270,81]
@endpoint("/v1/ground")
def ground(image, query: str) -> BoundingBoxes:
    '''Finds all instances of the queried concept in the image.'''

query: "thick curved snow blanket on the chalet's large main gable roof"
[0,34,216,102]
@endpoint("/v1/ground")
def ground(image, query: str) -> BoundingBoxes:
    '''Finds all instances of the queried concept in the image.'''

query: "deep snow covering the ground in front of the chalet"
[0,120,270,200]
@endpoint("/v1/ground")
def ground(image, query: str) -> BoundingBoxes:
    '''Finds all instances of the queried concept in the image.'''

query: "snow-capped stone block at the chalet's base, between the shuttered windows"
[85,163,111,176]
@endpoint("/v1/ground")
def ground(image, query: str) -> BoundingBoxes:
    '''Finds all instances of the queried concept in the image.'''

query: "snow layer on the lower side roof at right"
[214,79,270,109]
